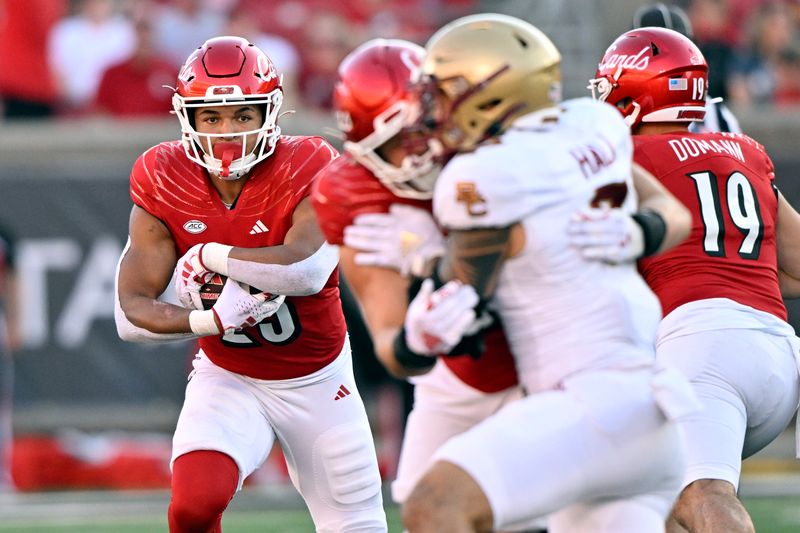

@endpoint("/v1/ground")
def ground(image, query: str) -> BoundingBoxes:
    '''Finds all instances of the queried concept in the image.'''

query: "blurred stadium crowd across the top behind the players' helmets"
[0,0,800,119]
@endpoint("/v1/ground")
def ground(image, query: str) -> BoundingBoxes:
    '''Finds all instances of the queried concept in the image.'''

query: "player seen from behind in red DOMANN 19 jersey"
[590,28,800,533]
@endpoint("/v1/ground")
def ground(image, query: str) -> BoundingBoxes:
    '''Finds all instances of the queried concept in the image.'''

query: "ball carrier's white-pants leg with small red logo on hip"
[261,344,387,533]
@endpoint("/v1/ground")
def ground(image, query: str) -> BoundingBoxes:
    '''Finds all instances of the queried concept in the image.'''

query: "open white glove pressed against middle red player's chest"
[344,204,445,277]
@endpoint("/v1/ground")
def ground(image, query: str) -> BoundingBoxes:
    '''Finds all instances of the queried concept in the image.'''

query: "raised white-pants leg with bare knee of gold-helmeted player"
[403,372,683,532]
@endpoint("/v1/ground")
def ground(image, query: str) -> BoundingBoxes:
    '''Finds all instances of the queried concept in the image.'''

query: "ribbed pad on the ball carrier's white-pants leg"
[314,424,381,505]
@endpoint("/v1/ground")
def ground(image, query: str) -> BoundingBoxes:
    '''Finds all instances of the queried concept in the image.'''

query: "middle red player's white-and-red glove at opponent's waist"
[405,279,480,355]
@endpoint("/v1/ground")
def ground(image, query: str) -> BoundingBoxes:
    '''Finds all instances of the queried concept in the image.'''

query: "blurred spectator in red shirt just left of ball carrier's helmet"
[95,15,175,117]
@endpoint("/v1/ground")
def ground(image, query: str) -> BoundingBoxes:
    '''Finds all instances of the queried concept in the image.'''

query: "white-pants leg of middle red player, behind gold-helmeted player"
[392,361,522,504]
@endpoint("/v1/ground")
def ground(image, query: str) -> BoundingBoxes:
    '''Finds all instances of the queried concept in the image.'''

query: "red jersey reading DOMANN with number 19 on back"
[633,132,786,320]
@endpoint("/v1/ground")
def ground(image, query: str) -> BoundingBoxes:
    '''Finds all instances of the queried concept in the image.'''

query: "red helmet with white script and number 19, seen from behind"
[588,27,708,127]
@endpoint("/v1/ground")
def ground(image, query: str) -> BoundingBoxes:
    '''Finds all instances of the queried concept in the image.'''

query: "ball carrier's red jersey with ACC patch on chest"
[130,136,346,379]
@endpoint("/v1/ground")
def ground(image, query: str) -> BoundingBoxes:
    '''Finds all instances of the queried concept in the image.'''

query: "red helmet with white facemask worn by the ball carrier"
[172,36,283,180]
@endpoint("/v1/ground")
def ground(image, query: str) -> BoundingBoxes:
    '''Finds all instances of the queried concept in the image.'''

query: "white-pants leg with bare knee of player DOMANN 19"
[658,329,798,533]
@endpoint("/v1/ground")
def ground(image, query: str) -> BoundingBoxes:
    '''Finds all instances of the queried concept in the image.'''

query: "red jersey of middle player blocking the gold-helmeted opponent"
[311,154,517,393]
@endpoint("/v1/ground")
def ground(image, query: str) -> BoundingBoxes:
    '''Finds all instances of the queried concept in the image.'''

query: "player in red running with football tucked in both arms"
[115,37,387,532]
